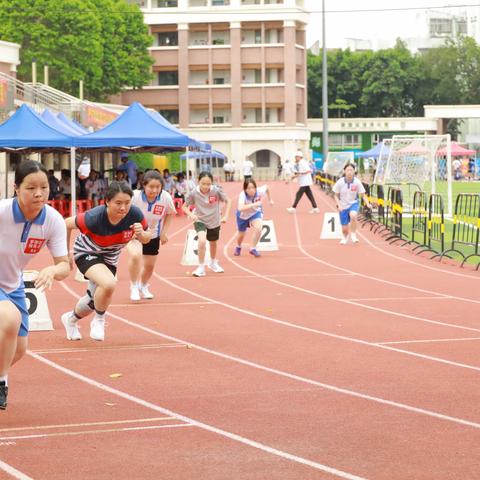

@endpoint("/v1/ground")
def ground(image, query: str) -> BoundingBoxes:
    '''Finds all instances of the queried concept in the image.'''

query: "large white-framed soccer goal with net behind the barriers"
[375,135,453,216]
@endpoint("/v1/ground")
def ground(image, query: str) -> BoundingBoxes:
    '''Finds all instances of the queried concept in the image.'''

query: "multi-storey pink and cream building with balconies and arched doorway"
[118,0,309,177]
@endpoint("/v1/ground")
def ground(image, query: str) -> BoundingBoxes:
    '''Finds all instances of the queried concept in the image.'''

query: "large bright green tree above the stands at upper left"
[0,0,151,100]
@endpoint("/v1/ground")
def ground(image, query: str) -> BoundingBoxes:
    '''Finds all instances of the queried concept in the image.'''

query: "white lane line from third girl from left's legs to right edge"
[149,272,480,372]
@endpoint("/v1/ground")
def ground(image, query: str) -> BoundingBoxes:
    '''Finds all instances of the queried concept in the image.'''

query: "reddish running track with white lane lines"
[0,183,480,480]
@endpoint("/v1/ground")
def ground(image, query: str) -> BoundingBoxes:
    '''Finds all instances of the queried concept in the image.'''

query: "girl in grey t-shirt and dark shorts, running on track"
[182,172,231,277]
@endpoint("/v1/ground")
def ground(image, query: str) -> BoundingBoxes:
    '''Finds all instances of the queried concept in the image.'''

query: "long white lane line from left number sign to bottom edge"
[28,348,365,480]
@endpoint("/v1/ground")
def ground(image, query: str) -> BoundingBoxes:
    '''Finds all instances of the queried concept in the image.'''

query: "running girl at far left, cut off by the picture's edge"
[0,160,70,410]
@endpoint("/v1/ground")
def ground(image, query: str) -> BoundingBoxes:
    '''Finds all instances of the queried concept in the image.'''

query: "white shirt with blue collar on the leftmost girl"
[0,198,68,293]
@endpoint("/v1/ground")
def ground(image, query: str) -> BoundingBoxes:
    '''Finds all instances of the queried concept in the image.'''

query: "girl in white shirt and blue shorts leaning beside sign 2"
[233,179,273,257]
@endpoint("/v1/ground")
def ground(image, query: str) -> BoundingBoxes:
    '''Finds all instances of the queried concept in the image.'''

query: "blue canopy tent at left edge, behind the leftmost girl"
[0,105,79,206]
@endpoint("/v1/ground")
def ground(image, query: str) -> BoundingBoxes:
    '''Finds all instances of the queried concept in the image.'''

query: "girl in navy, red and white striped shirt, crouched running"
[62,181,151,341]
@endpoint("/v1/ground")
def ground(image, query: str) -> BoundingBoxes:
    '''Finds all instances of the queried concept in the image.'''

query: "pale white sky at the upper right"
[305,0,480,48]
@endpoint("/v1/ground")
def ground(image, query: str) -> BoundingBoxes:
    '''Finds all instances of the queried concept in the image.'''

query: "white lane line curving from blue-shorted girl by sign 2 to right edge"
[223,235,480,332]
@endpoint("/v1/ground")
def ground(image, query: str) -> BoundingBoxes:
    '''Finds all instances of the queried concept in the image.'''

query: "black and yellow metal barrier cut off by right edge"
[439,193,480,270]
